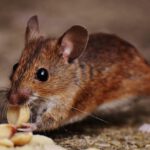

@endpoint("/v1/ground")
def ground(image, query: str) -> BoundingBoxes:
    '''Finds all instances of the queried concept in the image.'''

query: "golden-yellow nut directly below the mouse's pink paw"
[11,132,33,146]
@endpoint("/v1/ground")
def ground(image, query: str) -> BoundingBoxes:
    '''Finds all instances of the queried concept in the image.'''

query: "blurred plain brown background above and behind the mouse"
[0,0,150,88]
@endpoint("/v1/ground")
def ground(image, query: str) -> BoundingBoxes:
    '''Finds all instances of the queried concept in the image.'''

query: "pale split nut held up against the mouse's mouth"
[7,105,30,126]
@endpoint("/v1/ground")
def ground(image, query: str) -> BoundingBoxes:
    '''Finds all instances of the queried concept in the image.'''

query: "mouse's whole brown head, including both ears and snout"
[8,16,88,105]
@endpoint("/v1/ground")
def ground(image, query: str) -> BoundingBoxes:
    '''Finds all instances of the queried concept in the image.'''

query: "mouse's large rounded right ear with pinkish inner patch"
[58,25,89,63]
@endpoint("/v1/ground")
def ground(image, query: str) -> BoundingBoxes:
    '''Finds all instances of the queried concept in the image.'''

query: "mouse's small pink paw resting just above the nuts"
[17,123,37,132]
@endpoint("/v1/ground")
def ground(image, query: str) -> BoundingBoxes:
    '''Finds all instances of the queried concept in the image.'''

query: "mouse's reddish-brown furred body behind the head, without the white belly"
[71,33,150,115]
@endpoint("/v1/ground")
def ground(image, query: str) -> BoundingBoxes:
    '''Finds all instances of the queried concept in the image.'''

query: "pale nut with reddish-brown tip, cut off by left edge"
[0,124,16,139]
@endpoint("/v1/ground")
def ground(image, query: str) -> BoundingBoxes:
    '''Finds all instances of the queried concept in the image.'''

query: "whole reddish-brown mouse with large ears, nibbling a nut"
[8,16,150,131]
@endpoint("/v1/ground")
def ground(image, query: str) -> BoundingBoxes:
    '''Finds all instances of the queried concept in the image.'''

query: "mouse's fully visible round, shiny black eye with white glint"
[36,68,48,82]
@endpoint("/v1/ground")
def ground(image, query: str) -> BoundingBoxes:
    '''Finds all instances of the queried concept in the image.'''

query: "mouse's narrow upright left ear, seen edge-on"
[25,16,40,44]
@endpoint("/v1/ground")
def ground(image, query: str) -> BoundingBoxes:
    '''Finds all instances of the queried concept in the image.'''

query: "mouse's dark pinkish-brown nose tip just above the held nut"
[8,89,31,105]
